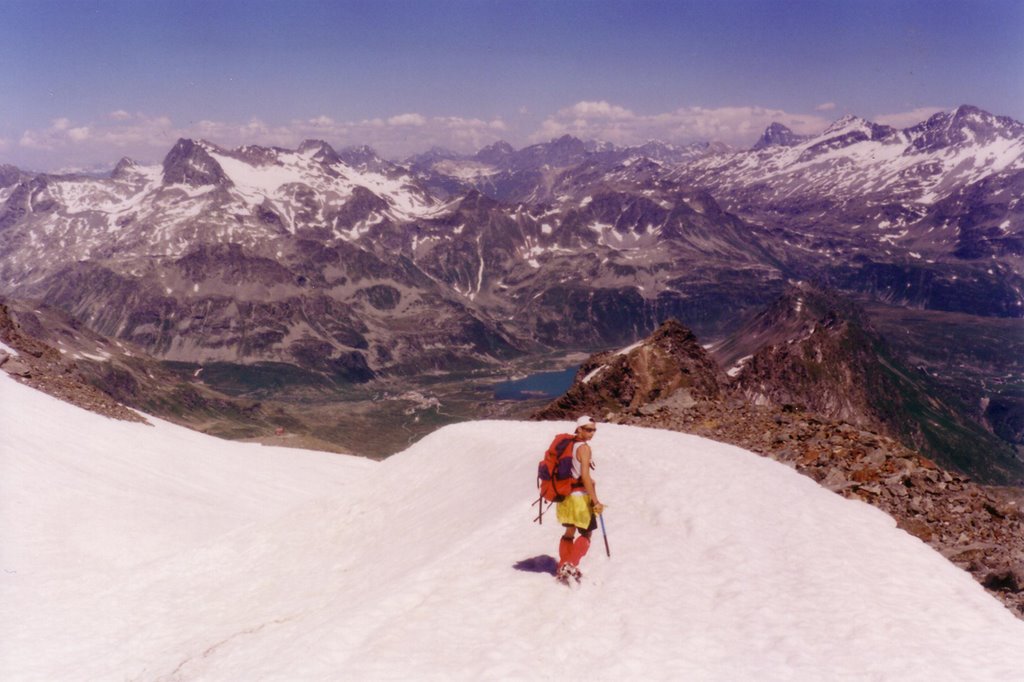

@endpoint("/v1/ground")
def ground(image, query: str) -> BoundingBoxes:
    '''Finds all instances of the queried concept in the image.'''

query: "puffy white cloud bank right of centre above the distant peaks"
[531,101,829,145]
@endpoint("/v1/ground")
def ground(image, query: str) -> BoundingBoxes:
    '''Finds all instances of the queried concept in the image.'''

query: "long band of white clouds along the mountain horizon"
[22,100,941,173]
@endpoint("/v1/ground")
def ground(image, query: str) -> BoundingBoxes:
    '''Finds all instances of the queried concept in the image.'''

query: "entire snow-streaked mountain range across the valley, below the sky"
[0,105,1024,473]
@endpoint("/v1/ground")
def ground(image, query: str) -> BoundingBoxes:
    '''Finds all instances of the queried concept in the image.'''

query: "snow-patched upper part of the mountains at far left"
[1,140,446,280]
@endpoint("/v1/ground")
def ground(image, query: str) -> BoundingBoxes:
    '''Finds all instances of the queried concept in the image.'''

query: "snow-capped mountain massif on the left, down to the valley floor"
[0,140,536,382]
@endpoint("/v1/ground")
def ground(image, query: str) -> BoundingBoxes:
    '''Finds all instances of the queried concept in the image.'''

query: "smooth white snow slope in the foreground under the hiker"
[0,377,1024,680]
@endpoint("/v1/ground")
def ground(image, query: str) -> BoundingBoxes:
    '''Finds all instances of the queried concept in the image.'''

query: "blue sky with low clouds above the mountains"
[0,0,1024,170]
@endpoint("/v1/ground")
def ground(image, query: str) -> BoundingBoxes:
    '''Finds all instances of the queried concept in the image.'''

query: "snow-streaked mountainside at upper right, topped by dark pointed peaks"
[676,106,1024,263]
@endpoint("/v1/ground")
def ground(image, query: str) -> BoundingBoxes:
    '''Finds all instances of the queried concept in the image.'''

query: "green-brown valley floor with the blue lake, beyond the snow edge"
[172,351,589,459]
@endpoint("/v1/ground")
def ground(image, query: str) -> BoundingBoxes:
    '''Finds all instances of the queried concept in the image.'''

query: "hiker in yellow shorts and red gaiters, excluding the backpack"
[555,417,604,582]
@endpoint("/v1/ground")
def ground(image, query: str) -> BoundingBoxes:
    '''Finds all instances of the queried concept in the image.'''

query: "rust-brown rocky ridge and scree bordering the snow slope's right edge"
[535,313,1024,619]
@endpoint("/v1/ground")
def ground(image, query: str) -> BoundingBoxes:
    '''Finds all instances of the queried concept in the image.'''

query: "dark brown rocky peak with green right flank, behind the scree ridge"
[723,285,1024,483]
